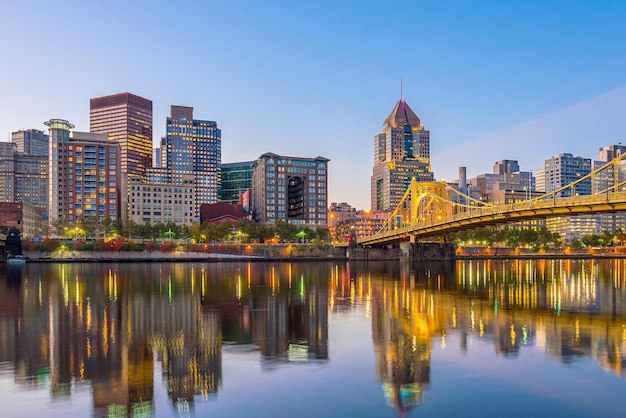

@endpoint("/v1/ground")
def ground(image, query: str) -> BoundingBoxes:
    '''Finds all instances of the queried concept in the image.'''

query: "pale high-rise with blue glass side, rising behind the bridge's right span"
[545,153,591,197]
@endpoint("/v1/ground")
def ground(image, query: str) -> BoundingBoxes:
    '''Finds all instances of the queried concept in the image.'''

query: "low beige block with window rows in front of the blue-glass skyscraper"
[128,173,196,225]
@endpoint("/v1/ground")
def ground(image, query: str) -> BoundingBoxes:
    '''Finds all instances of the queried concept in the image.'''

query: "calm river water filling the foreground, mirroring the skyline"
[0,260,626,417]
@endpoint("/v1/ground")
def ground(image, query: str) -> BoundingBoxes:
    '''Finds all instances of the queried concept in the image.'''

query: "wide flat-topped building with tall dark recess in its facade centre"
[252,152,330,227]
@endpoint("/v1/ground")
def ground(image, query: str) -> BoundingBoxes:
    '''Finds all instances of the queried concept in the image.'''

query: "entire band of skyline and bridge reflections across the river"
[0,260,626,417]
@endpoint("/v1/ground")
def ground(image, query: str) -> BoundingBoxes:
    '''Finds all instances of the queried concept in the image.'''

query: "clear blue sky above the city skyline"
[0,0,626,209]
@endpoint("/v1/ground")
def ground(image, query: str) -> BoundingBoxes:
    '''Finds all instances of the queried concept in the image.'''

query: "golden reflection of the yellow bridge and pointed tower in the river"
[330,259,626,415]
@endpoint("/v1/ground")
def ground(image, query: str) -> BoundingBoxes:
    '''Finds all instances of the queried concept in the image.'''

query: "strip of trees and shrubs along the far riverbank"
[15,239,626,262]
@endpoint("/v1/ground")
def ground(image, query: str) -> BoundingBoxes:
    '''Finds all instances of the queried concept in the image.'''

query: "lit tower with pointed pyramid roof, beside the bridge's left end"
[371,99,433,211]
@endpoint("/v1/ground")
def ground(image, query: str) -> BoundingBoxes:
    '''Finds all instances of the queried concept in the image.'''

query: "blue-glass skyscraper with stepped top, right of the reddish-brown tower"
[161,106,222,220]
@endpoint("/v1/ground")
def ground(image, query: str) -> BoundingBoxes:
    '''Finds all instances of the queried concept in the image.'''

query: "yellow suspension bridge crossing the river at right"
[357,154,626,245]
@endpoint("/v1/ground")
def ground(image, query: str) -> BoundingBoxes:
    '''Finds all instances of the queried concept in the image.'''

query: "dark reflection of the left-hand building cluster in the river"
[0,263,330,417]
